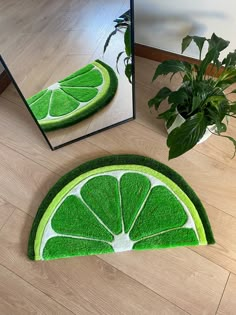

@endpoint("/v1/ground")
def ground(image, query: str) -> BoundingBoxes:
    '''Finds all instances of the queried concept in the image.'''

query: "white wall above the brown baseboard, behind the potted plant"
[135,0,236,58]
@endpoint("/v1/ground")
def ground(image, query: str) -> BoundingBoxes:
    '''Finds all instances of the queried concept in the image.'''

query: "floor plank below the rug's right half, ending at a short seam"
[101,248,228,314]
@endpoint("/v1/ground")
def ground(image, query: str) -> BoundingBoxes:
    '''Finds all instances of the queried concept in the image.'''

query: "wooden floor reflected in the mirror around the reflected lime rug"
[0,0,133,147]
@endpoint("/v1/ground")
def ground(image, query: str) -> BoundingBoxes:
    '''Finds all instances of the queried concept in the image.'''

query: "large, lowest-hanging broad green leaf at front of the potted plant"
[167,112,207,159]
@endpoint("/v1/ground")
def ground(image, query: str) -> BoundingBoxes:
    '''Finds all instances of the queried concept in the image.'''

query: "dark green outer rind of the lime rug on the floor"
[28,155,215,260]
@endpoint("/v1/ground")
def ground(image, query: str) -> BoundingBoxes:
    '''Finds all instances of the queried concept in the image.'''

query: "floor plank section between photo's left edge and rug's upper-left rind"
[0,144,59,216]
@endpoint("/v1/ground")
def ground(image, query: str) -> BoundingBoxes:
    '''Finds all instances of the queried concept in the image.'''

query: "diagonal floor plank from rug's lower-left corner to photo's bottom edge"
[0,210,188,315]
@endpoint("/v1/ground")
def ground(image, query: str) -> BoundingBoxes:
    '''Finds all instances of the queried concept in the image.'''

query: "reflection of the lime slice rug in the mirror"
[27,60,118,131]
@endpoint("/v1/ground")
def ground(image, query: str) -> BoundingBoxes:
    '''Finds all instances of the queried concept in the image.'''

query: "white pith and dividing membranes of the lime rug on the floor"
[40,170,199,260]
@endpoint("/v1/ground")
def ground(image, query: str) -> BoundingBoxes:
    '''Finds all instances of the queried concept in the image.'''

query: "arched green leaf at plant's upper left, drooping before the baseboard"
[152,60,192,81]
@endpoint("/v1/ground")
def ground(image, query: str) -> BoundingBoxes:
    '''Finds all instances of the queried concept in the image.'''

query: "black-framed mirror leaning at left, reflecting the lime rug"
[0,0,134,149]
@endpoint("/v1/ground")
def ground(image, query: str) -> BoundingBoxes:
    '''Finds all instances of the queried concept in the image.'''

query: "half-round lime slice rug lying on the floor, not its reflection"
[28,155,214,260]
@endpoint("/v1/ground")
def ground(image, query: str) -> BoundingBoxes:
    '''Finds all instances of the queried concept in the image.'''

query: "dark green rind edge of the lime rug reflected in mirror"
[30,60,118,131]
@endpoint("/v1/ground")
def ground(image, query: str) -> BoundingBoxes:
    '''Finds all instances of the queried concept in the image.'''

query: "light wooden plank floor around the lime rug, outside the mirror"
[0,58,236,315]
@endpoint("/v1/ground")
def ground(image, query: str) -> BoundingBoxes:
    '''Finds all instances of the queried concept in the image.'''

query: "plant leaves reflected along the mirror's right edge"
[103,11,132,83]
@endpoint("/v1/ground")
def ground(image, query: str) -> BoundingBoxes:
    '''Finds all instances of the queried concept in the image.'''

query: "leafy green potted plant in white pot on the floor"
[148,33,236,159]
